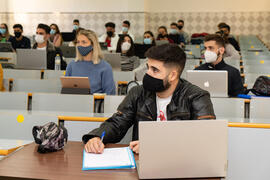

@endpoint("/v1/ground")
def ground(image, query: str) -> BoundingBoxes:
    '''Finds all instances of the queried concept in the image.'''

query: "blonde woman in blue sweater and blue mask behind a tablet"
[66,30,115,95]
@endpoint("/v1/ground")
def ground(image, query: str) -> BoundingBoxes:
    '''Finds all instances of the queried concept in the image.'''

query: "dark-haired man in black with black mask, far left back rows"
[8,24,31,50]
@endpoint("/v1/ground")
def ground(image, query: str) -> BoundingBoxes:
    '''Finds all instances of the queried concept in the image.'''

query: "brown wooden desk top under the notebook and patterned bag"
[0,141,221,180]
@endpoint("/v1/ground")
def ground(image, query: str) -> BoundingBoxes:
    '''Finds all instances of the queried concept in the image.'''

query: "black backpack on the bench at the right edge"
[246,76,270,96]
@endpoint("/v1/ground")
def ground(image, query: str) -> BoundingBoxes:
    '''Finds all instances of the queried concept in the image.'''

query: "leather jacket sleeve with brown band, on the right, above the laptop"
[190,91,216,120]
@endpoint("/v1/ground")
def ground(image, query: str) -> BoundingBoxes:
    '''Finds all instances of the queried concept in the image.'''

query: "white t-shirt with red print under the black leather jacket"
[156,96,172,121]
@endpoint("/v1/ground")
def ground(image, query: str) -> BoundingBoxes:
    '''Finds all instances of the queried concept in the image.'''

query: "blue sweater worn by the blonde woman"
[66,60,115,95]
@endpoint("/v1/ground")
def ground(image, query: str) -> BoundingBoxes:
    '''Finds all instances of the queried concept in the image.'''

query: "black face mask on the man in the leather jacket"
[143,73,170,92]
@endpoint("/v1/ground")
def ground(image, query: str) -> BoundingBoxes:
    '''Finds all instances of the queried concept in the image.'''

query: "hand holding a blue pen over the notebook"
[84,137,104,154]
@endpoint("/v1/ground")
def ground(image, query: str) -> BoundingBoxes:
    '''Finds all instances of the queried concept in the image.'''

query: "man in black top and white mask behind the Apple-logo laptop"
[195,34,244,97]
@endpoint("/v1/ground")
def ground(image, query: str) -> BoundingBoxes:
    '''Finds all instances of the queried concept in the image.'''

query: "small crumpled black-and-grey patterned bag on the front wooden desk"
[32,122,68,153]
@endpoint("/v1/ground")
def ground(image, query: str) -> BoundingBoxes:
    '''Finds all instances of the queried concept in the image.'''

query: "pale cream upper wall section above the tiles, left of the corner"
[0,0,144,13]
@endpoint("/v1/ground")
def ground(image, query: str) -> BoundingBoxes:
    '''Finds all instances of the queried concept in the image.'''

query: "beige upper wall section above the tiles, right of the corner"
[145,0,270,12]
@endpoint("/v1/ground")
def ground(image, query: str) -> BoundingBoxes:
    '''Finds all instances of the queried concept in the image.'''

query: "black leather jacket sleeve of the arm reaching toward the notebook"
[82,87,138,144]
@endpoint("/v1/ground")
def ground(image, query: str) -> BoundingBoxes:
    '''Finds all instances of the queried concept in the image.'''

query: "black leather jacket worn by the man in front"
[82,79,215,143]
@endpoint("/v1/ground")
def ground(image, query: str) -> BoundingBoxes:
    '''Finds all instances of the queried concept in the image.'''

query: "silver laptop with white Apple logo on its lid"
[186,70,228,97]
